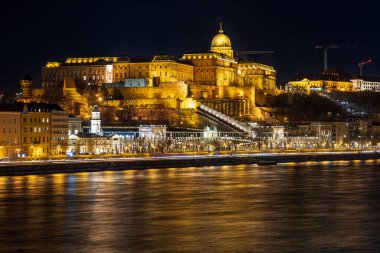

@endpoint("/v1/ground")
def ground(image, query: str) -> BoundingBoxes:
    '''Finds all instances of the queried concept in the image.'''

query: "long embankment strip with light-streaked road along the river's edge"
[0,150,380,175]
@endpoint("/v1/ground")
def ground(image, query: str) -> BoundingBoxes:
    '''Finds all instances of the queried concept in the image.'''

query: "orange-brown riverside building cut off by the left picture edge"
[0,104,21,157]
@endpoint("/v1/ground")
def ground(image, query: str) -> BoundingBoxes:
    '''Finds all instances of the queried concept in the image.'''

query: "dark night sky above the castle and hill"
[0,0,380,91]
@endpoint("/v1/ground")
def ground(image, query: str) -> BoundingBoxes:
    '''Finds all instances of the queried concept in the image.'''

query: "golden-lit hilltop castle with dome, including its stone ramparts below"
[21,24,276,128]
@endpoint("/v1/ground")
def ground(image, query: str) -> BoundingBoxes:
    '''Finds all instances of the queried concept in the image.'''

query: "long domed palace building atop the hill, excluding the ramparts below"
[42,23,276,89]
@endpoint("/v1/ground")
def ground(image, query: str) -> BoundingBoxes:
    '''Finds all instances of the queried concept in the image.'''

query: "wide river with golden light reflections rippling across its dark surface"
[0,161,380,252]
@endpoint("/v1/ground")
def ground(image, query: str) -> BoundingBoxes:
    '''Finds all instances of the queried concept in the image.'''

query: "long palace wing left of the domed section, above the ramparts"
[42,55,193,88]
